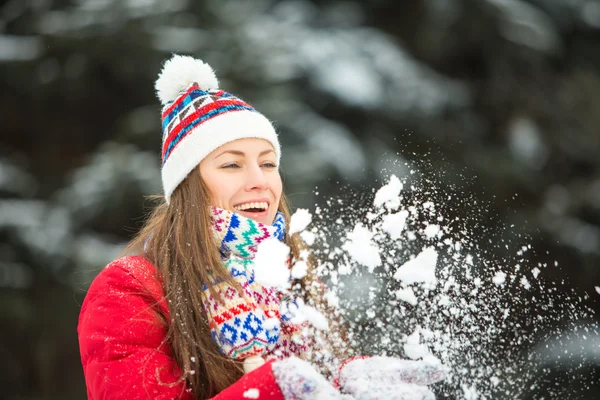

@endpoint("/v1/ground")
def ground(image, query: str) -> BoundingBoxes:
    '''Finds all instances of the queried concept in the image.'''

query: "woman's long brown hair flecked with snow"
[124,169,350,399]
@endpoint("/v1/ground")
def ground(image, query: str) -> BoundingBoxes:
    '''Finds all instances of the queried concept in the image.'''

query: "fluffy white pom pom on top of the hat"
[154,54,219,105]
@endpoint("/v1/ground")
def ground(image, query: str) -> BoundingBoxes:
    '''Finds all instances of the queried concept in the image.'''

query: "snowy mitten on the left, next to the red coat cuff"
[272,357,353,400]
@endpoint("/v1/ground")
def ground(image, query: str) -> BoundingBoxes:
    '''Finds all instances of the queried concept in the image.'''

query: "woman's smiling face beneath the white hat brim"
[199,139,283,225]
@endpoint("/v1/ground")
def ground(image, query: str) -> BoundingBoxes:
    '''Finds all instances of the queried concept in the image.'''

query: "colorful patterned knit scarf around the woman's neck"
[202,207,307,360]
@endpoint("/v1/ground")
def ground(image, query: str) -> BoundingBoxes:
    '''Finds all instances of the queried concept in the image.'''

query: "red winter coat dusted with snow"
[77,256,284,400]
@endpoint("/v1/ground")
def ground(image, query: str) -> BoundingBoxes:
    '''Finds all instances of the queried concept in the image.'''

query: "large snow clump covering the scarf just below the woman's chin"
[254,238,290,289]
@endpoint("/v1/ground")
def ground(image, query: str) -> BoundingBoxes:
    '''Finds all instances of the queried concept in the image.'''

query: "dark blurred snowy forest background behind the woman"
[0,0,600,399]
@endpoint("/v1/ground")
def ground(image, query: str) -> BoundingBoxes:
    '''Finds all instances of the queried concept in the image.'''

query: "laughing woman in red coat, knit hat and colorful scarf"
[78,56,446,400]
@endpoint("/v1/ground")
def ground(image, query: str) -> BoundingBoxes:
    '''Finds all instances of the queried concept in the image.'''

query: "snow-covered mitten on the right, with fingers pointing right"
[339,357,447,400]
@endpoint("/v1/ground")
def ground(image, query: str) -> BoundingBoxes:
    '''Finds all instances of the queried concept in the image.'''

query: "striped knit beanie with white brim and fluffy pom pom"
[155,55,281,203]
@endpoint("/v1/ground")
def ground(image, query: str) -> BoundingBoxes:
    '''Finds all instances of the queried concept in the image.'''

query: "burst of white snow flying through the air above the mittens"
[294,173,600,399]
